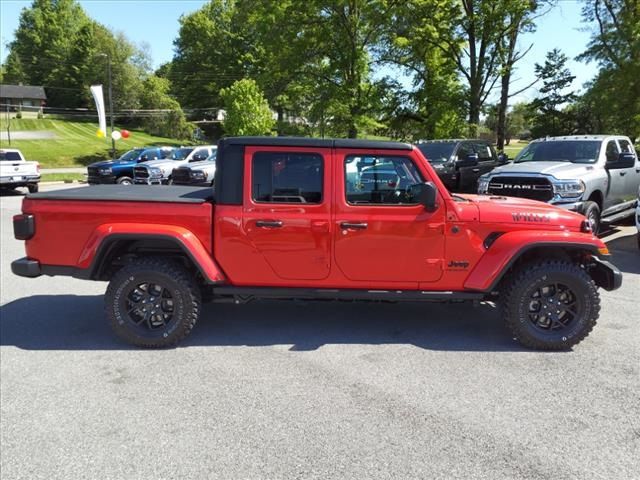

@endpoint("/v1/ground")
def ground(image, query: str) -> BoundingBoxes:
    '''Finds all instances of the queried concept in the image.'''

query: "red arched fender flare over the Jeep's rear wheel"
[77,223,225,283]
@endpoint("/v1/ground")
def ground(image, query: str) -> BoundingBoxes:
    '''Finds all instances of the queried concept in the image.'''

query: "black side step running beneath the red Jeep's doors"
[212,286,486,303]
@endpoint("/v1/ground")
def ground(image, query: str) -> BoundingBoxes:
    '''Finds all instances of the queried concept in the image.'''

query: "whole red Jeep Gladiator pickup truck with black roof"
[12,137,622,350]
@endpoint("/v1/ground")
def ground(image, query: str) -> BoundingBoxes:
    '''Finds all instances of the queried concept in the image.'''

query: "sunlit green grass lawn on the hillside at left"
[0,116,189,168]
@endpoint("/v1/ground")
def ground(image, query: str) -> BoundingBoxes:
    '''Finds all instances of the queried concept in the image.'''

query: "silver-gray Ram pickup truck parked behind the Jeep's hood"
[478,135,640,232]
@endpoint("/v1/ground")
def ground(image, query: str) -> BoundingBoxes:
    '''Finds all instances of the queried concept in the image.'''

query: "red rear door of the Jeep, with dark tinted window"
[242,147,331,285]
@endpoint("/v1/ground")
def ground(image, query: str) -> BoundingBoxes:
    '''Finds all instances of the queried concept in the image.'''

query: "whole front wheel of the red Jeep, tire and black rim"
[502,260,600,350]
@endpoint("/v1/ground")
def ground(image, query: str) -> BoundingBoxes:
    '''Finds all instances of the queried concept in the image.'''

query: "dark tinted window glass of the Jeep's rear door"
[251,152,324,204]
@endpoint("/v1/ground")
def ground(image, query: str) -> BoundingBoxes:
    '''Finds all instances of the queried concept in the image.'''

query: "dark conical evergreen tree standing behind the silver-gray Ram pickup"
[531,48,577,137]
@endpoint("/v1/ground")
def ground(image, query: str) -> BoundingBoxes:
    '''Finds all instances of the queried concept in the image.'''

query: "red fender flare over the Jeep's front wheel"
[464,230,608,292]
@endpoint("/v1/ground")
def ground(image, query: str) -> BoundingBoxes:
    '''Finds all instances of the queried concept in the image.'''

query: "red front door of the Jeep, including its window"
[333,149,445,288]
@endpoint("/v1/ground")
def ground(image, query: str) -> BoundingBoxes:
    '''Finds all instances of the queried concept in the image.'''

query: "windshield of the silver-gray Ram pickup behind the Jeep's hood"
[514,140,602,163]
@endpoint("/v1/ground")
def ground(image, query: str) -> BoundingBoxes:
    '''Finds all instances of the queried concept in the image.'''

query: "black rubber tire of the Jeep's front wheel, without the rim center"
[500,260,600,350]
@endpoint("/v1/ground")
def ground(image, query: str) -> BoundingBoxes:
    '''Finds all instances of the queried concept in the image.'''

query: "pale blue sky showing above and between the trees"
[0,0,597,102]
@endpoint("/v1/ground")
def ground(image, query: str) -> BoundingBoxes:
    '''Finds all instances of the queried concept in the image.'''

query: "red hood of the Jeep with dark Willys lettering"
[460,195,584,230]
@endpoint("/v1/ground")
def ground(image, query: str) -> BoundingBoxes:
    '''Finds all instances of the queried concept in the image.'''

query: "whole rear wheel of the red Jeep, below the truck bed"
[105,257,201,348]
